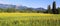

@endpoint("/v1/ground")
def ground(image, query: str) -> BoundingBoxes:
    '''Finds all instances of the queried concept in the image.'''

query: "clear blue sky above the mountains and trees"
[0,0,60,8]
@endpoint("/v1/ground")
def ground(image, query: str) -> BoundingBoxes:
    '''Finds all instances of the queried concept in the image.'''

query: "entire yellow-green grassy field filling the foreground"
[0,13,60,26]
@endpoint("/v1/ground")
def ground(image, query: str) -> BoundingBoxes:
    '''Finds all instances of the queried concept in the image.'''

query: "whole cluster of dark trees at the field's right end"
[46,1,60,14]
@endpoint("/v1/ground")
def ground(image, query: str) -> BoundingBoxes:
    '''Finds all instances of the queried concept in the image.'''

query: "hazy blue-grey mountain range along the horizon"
[0,4,46,11]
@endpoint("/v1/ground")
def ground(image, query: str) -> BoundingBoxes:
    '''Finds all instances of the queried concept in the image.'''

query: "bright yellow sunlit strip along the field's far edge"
[0,13,53,16]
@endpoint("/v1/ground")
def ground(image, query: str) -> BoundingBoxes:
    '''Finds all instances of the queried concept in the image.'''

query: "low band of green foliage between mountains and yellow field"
[0,8,43,13]
